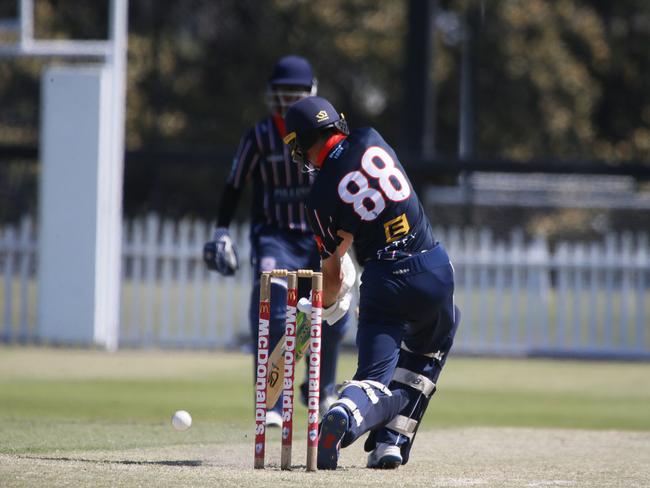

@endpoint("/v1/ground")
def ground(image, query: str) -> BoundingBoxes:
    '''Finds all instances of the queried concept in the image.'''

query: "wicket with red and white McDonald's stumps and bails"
[254,269,323,471]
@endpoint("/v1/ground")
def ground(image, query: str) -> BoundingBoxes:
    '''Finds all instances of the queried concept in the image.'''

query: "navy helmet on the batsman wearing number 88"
[284,97,349,168]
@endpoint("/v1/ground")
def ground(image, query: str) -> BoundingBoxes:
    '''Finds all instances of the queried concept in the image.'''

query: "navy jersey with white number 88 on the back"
[306,128,434,263]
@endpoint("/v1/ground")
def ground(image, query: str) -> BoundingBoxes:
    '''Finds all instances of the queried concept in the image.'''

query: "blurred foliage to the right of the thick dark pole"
[437,0,650,161]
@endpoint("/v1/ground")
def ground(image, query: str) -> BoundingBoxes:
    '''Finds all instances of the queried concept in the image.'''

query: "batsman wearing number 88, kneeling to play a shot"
[284,96,460,469]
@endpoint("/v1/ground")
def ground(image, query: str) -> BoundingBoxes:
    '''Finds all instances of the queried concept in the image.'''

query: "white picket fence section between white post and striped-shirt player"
[119,216,252,348]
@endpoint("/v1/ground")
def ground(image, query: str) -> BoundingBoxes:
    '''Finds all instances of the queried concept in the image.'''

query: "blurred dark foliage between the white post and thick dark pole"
[120,0,403,148]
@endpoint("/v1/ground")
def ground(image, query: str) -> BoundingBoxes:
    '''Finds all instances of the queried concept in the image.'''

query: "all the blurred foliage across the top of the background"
[0,0,650,160]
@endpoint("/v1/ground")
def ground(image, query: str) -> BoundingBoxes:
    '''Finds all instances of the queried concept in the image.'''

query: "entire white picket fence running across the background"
[0,216,650,359]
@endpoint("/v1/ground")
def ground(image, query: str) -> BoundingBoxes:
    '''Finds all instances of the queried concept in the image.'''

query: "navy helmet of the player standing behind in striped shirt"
[266,55,318,117]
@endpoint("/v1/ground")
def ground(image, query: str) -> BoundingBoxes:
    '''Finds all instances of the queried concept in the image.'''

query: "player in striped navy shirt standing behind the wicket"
[203,56,354,427]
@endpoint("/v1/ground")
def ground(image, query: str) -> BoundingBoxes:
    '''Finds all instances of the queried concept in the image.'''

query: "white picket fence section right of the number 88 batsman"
[436,229,650,358]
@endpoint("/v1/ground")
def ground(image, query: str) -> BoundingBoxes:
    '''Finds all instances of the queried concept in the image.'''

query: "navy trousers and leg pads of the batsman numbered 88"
[340,244,459,462]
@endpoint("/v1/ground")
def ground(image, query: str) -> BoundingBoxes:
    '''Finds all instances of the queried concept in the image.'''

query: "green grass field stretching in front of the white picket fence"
[0,347,650,486]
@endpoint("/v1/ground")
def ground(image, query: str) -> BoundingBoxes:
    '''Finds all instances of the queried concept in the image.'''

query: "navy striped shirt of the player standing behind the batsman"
[227,116,311,233]
